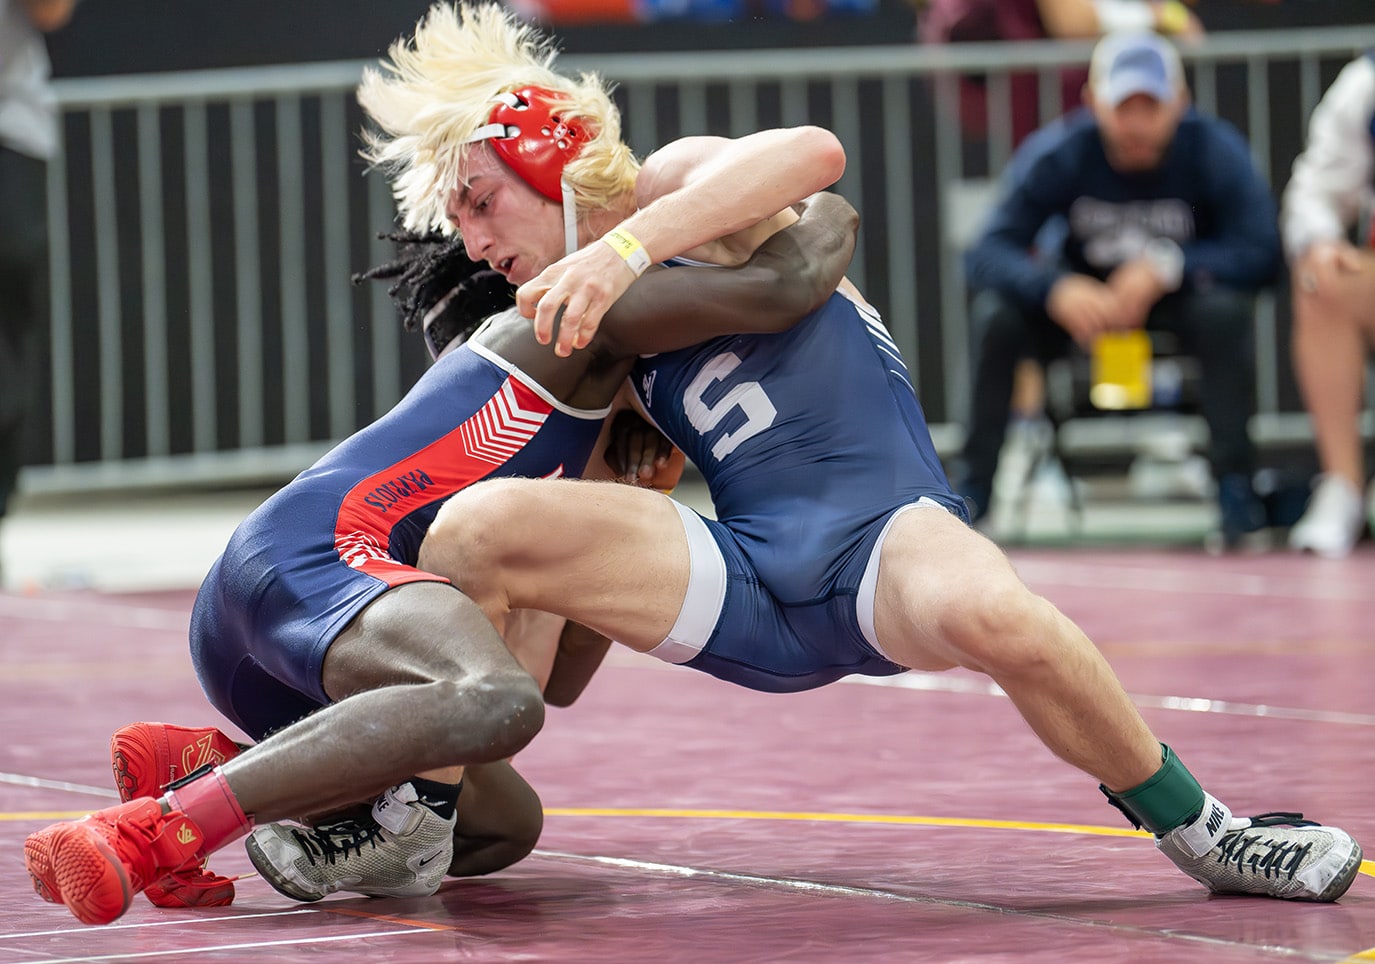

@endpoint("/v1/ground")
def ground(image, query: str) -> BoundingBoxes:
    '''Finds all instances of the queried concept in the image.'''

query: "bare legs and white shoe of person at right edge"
[1290,250,1375,557]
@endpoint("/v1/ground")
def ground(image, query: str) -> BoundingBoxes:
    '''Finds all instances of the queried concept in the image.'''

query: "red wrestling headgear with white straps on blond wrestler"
[468,87,591,254]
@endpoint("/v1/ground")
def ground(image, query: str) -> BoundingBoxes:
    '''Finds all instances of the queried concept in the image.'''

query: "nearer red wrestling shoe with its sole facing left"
[23,798,204,924]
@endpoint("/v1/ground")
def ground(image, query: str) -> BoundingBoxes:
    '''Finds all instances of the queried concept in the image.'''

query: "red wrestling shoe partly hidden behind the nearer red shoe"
[112,723,241,908]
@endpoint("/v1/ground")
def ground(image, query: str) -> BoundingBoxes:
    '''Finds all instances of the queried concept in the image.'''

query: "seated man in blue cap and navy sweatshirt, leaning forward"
[956,33,1280,546]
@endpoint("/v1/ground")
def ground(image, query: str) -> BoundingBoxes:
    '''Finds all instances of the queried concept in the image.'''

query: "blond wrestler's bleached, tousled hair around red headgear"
[358,3,639,232]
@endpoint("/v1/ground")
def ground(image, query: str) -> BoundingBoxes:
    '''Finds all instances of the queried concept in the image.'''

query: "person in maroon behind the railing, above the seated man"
[919,0,1203,146]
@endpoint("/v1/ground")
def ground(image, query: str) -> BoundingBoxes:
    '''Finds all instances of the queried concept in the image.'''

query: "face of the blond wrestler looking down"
[444,146,564,285]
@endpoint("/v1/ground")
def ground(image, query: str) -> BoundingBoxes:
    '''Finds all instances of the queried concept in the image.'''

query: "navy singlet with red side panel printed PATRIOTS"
[191,334,608,738]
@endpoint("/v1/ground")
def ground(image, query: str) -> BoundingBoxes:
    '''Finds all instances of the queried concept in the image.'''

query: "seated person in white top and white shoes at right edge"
[1280,54,1375,558]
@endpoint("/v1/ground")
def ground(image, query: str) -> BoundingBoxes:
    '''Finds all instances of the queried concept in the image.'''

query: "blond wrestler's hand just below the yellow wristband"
[516,242,635,358]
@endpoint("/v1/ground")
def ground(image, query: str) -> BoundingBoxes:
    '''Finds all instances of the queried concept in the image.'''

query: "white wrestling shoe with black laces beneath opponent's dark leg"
[245,784,455,901]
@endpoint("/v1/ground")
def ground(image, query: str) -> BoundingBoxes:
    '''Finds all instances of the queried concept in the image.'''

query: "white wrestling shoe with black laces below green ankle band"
[1155,796,1361,902]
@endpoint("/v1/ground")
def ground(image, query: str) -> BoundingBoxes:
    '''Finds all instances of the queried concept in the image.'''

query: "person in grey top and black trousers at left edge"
[0,0,76,566]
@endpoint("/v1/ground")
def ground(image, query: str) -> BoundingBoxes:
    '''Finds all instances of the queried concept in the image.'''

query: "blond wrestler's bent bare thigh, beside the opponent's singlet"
[421,479,689,650]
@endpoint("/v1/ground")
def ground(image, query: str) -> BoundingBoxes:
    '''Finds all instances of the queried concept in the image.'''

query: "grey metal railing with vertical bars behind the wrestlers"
[25,26,1375,490]
